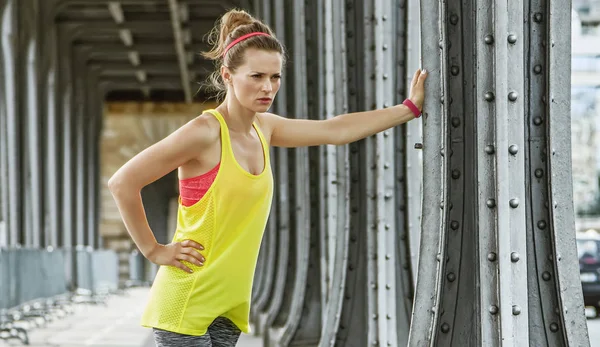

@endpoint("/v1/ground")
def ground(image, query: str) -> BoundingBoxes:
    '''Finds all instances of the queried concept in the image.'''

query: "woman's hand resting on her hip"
[146,240,205,273]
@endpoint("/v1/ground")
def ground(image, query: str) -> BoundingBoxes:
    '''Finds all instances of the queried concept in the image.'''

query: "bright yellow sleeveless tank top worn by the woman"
[141,110,273,335]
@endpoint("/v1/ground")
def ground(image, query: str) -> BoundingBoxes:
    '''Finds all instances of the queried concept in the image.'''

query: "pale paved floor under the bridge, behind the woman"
[0,288,600,347]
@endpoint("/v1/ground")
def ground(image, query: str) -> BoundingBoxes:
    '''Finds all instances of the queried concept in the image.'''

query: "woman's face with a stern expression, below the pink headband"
[223,48,282,112]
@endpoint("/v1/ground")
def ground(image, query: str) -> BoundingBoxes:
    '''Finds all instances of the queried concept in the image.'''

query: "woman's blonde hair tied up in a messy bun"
[201,9,285,99]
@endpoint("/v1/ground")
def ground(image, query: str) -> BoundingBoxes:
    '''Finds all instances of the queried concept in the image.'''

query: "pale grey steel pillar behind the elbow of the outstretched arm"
[319,0,354,346]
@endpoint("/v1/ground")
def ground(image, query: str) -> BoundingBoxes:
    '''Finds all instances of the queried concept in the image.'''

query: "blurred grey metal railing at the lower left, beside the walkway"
[0,248,120,344]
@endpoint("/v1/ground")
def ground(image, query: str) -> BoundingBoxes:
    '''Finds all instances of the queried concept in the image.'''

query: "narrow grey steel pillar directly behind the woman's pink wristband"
[392,1,421,346]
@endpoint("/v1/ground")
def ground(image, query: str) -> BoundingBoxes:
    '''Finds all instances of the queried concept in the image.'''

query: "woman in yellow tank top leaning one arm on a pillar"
[108,6,426,347]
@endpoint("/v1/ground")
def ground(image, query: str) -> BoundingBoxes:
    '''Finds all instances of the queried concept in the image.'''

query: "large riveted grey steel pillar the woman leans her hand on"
[409,0,589,346]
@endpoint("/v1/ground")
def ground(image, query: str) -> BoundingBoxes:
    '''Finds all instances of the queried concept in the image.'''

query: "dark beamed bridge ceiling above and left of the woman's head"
[49,0,251,101]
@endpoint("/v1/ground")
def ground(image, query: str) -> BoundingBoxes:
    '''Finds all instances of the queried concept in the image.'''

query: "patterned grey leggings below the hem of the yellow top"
[153,317,242,347]
